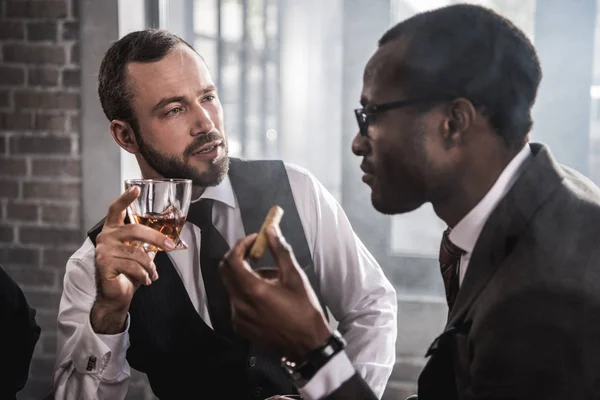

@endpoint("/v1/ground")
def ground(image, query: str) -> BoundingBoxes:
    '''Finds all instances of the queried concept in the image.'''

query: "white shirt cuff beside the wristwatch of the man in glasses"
[298,351,356,400]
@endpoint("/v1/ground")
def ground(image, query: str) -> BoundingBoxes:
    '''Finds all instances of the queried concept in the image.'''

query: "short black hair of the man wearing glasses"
[379,4,542,145]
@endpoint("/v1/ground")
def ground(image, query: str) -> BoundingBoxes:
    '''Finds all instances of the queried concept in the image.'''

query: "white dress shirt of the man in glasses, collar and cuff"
[300,145,531,400]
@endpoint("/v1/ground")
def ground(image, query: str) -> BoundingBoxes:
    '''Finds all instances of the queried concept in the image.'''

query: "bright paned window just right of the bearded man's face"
[186,0,280,158]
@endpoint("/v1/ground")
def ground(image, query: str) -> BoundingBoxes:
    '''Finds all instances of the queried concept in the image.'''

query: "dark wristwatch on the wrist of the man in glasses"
[281,331,346,387]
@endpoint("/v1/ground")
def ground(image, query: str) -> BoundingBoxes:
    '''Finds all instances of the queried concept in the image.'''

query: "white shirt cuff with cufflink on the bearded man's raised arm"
[72,313,131,381]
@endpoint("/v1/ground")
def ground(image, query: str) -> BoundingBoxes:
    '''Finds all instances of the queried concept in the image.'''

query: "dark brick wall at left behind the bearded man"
[0,0,83,400]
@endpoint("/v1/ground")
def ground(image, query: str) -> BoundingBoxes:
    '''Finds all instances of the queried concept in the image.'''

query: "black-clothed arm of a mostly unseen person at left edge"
[0,267,40,400]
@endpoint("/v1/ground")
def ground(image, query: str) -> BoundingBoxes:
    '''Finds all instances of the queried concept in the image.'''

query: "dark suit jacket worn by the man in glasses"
[328,144,600,400]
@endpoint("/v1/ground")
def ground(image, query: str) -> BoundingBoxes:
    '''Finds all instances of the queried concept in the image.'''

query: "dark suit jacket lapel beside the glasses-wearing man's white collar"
[446,143,564,329]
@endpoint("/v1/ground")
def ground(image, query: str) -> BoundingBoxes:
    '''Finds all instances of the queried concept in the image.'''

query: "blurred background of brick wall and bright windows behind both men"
[0,0,600,399]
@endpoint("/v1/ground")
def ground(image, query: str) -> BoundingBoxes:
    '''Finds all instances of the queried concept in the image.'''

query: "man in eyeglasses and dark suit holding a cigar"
[221,4,600,400]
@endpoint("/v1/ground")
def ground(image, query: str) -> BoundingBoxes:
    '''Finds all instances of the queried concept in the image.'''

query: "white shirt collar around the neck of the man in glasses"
[450,144,531,253]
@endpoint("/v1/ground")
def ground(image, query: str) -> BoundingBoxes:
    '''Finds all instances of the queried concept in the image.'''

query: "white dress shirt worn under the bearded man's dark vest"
[54,165,397,400]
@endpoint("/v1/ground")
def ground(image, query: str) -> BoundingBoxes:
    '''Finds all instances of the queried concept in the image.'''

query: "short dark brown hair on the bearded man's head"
[98,29,194,126]
